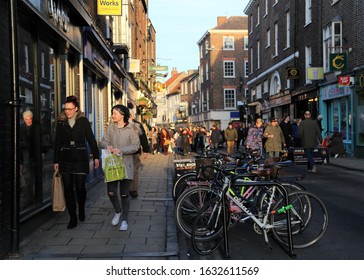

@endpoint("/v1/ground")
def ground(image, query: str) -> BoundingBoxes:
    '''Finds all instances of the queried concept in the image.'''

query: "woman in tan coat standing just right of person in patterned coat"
[263,118,286,158]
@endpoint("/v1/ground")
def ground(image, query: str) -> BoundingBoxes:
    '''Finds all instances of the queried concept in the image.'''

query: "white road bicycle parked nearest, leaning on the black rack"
[191,166,328,255]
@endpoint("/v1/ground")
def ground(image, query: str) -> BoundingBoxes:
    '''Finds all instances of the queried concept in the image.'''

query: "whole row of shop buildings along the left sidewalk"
[0,0,155,258]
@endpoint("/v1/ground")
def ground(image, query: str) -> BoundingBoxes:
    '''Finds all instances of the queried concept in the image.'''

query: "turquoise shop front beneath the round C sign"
[320,84,354,156]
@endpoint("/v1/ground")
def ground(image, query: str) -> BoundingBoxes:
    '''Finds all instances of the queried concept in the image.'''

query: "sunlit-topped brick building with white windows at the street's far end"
[196,16,248,129]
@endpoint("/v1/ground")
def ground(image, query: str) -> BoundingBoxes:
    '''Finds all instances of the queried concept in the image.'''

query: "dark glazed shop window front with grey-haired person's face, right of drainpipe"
[17,1,82,220]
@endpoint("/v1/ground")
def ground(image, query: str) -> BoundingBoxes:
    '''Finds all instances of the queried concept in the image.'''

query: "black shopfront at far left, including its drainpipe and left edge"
[0,0,90,258]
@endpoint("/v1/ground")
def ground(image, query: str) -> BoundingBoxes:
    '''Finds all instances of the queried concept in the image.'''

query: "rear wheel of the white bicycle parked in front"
[270,191,328,249]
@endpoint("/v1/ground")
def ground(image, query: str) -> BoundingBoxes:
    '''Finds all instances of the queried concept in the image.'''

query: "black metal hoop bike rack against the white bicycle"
[222,179,296,259]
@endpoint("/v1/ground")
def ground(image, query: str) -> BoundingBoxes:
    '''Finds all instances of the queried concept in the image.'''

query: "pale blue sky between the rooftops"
[149,0,249,74]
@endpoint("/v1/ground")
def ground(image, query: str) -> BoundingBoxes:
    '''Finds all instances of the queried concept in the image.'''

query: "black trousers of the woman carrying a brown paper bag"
[61,173,86,220]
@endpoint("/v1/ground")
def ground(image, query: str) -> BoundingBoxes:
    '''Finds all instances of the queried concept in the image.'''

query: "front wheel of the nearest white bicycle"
[191,198,230,255]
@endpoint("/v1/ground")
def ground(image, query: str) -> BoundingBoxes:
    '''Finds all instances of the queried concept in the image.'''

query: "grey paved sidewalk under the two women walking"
[20,154,179,260]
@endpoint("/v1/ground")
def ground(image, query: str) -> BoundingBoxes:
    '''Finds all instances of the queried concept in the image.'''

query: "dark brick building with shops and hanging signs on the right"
[244,0,363,157]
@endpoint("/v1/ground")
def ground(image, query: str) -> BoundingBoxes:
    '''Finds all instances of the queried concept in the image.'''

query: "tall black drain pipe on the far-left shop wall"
[8,0,21,259]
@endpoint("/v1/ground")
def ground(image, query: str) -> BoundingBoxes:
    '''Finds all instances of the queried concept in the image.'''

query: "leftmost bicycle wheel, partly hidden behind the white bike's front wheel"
[175,186,212,238]
